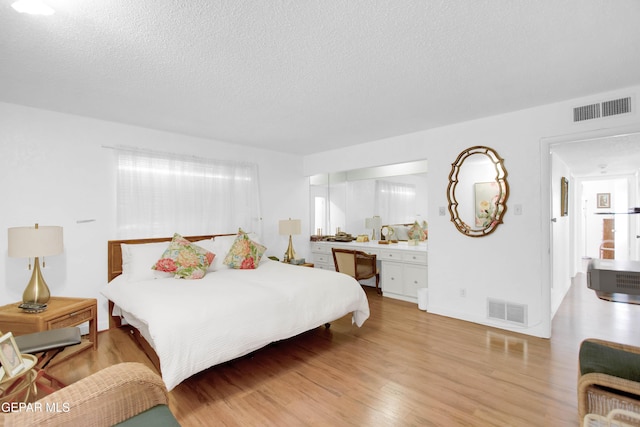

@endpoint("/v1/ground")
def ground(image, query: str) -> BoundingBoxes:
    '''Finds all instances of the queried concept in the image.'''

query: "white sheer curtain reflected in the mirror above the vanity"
[375,180,416,224]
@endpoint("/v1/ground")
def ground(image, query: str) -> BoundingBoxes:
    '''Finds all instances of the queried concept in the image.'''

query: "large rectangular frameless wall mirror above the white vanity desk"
[309,160,427,237]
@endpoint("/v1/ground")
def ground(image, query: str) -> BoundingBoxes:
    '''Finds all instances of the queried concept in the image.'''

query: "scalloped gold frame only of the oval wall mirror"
[447,145,509,237]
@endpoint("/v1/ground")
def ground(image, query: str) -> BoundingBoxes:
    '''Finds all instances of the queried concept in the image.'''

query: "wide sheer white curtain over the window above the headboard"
[116,147,262,238]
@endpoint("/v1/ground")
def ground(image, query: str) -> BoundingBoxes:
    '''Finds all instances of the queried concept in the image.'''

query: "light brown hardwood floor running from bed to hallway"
[50,275,640,427]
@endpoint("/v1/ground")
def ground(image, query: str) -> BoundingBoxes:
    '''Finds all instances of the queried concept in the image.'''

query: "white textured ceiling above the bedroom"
[0,0,640,154]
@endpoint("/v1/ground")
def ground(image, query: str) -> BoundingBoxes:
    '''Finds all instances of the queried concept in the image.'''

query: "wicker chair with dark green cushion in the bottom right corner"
[578,338,640,425]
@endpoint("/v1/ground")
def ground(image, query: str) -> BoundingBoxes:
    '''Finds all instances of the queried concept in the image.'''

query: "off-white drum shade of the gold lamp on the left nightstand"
[8,224,64,258]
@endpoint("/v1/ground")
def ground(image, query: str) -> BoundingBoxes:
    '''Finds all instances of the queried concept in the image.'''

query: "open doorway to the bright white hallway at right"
[549,129,640,318]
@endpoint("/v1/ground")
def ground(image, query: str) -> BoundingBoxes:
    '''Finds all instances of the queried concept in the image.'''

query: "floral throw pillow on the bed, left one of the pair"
[151,233,215,279]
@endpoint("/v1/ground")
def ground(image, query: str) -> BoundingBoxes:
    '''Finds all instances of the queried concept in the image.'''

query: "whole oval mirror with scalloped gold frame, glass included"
[447,146,509,237]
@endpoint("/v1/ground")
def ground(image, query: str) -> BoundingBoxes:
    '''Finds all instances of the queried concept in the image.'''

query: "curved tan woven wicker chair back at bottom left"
[0,362,179,427]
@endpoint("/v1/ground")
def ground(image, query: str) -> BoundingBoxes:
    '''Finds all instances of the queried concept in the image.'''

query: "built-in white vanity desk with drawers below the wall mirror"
[311,241,427,302]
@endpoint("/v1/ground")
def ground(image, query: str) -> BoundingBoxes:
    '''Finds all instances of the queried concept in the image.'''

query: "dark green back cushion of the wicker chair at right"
[579,341,640,382]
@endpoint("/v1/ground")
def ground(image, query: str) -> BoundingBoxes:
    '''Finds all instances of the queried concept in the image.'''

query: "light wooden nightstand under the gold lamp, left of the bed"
[0,297,98,353]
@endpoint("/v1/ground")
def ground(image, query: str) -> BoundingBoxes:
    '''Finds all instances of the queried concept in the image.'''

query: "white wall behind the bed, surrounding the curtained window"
[0,103,309,329]
